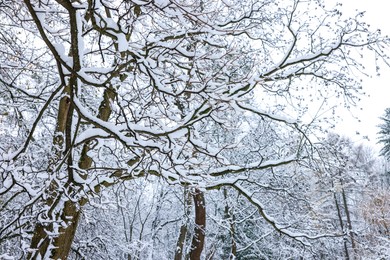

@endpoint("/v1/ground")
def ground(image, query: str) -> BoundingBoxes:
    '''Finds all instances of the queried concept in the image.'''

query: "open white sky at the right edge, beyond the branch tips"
[325,0,390,150]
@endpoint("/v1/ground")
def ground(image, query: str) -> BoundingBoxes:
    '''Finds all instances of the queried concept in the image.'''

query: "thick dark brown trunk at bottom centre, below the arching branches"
[190,189,206,260]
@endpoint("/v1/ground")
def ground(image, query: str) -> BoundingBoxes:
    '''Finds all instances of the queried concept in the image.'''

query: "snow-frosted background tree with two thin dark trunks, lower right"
[318,134,368,259]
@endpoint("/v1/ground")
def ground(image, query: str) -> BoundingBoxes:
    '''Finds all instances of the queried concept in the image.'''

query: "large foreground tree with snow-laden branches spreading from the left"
[0,0,388,259]
